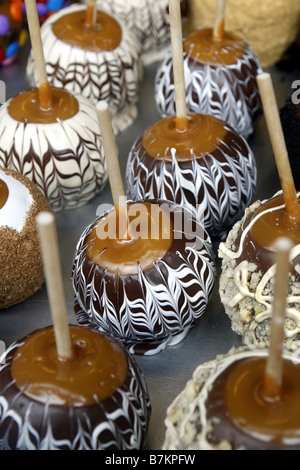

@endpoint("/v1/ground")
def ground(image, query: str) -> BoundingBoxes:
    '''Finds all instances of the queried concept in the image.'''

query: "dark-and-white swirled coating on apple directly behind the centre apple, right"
[126,126,257,239]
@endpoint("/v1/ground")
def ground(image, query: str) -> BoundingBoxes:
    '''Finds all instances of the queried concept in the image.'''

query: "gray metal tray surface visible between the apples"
[0,42,299,450]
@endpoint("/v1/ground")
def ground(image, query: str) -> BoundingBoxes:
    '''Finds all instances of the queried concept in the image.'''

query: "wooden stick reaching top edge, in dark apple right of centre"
[169,0,188,131]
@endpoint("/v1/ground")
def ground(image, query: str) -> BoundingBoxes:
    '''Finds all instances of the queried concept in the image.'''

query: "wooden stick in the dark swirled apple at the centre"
[96,101,128,239]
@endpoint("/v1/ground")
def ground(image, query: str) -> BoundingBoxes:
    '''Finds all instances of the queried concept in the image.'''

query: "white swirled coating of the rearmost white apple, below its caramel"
[26,5,143,133]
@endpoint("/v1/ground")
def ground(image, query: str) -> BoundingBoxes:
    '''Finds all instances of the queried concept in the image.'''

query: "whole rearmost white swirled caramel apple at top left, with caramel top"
[27,5,143,133]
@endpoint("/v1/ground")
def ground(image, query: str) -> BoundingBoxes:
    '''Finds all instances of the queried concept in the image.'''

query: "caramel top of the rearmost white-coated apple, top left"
[52,9,122,52]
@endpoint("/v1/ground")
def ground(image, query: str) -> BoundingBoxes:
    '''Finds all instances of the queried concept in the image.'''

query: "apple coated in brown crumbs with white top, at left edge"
[0,168,51,309]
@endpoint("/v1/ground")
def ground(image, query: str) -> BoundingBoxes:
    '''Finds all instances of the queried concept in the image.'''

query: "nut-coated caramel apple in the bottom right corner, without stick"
[163,348,300,451]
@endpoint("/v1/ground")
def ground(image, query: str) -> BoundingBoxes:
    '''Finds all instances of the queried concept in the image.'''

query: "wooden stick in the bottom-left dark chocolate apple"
[36,212,72,360]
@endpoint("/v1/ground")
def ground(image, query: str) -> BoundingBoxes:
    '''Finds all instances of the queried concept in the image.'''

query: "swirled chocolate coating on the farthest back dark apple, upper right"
[155,32,262,139]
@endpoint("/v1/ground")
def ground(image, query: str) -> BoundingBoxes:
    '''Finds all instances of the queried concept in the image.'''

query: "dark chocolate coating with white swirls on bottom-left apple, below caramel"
[0,328,151,450]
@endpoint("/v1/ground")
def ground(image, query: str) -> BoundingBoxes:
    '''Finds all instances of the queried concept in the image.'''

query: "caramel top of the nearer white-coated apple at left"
[8,88,79,124]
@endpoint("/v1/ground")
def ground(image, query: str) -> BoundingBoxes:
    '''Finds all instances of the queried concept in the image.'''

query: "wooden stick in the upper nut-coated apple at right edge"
[257,73,300,222]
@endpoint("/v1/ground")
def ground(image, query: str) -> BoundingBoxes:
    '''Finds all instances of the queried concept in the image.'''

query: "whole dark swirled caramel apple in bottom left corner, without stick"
[0,325,150,450]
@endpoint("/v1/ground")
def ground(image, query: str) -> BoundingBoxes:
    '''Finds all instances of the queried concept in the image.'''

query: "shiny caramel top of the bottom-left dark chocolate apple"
[11,326,128,407]
